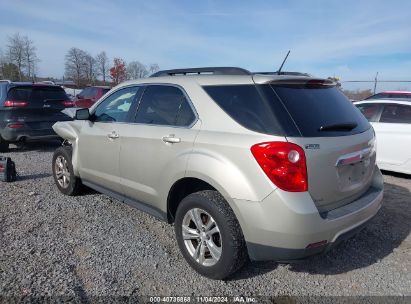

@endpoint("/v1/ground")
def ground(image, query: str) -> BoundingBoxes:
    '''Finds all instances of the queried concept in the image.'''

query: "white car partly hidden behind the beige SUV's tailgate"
[354,99,411,174]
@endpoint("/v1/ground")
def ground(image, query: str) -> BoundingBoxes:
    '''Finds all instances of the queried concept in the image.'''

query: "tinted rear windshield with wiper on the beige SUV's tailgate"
[272,85,371,137]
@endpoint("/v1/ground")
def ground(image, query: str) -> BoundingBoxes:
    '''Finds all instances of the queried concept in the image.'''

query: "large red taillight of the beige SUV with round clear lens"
[251,142,308,192]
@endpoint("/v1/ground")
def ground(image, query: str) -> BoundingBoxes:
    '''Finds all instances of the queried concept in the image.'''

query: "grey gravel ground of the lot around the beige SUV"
[0,143,411,303]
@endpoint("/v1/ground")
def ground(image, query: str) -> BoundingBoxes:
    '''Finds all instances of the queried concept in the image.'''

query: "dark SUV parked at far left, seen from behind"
[0,81,74,151]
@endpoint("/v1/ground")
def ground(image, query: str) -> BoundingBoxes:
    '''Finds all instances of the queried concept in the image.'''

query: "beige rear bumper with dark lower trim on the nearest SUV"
[234,167,383,261]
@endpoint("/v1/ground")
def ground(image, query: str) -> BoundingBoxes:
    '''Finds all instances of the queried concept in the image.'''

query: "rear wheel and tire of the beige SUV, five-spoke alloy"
[174,190,248,280]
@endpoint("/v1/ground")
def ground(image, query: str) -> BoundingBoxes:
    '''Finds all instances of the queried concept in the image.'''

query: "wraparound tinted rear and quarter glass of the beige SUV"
[204,84,371,137]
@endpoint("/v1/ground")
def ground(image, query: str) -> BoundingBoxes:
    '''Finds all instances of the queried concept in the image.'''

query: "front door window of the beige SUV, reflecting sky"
[93,87,141,122]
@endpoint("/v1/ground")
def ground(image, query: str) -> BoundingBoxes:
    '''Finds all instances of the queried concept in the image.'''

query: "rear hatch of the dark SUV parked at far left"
[7,85,73,130]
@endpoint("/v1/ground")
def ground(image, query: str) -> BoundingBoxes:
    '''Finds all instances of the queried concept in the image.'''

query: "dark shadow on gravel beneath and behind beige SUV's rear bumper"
[230,183,411,281]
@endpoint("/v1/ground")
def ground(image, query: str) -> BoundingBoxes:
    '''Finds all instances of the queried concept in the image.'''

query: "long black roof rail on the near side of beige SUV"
[150,67,251,77]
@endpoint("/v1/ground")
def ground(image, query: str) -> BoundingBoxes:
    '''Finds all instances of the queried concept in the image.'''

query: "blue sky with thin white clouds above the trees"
[0,0,411,89]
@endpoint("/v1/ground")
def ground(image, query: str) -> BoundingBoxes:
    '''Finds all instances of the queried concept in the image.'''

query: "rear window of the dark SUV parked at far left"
[7,86,69,103]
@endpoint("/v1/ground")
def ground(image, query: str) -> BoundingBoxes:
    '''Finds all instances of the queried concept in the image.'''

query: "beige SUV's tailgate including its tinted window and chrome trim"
[270,78,376,212]
